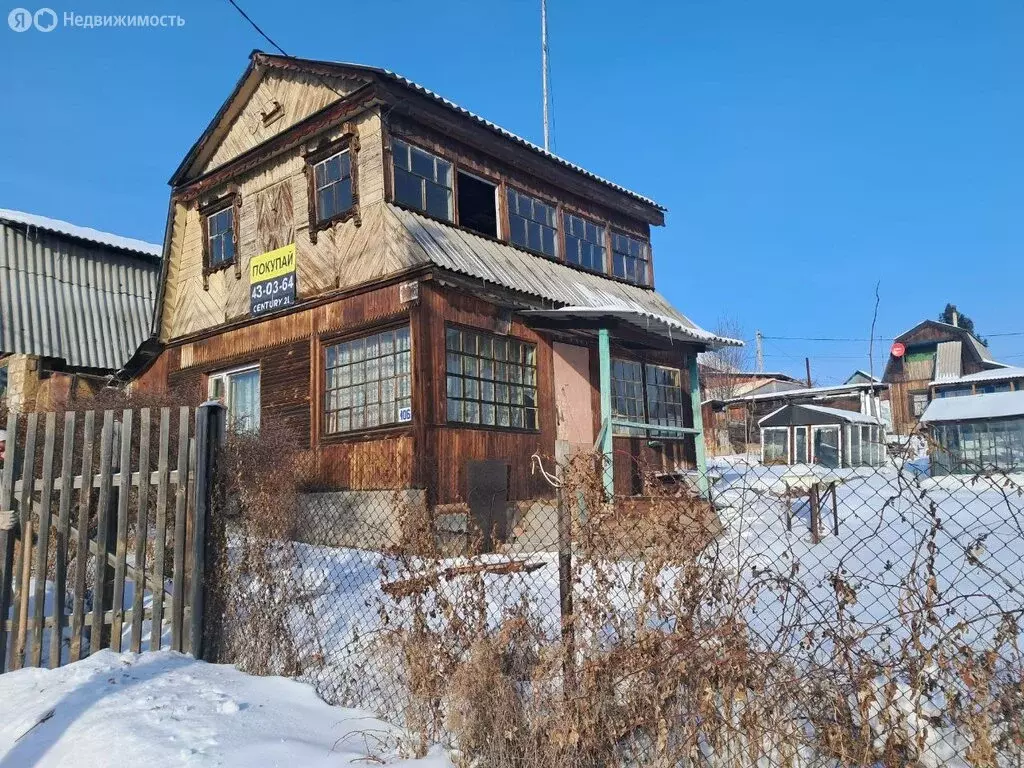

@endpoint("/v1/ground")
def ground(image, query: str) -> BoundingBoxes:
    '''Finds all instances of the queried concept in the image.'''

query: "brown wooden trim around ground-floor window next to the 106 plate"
[319,312,415,438]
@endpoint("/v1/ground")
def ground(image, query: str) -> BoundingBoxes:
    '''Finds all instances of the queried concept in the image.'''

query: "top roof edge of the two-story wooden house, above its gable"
[171,50,667,217]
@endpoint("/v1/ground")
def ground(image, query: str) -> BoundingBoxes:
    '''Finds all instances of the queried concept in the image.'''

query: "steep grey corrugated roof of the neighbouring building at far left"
[0,221,160,371]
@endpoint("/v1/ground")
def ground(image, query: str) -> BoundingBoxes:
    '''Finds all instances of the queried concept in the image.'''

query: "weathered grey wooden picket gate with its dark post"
[0,403,223,672]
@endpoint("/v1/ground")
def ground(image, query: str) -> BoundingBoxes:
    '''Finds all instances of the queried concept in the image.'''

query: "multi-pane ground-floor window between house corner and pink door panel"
[444,326,539,430]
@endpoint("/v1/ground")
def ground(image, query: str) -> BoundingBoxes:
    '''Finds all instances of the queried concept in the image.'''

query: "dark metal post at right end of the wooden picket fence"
[189,400,226,658]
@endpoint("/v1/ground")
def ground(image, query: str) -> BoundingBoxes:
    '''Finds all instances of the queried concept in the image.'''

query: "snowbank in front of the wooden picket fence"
[0,650,452,768]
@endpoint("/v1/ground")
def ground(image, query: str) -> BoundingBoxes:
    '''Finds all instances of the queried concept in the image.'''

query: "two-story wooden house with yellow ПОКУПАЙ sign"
[135,52,738,512]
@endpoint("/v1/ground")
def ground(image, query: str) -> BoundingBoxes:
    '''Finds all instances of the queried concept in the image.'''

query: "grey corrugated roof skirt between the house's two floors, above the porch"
[387,205,731,343]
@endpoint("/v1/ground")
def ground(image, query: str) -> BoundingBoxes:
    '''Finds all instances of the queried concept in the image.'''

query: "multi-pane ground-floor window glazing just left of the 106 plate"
[324,326,413,434]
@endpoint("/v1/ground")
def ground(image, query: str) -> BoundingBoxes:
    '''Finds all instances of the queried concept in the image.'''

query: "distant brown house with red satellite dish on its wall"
[882,321,1007,435]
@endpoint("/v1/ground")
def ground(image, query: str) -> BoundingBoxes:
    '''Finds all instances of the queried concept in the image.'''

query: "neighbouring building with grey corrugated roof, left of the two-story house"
[0,209,161,411]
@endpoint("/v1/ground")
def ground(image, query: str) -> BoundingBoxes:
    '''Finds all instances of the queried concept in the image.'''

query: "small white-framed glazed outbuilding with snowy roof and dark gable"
[758,403,886,468]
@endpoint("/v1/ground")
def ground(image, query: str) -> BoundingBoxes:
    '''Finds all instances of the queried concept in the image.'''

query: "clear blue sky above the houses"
[0,0,1024,383]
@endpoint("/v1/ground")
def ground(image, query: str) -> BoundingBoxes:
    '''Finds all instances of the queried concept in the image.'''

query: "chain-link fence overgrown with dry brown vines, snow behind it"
[207,430,1024,767]
